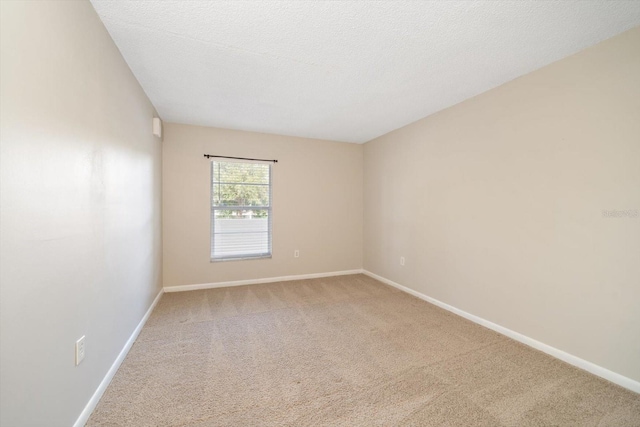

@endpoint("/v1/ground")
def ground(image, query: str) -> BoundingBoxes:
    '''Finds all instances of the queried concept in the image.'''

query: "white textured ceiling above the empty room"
[91,0,640,143]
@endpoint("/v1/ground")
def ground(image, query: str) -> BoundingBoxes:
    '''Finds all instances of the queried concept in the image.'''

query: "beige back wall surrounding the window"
[162,123,363,286]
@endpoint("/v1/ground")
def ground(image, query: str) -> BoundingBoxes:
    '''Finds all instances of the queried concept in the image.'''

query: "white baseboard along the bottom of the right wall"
[362,270,640,393]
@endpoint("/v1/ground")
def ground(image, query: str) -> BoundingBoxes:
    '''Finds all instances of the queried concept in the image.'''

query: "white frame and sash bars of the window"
[209,158,273,263]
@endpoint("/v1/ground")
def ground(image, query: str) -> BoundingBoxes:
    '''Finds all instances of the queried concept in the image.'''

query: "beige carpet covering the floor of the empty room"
[88,275,640,427]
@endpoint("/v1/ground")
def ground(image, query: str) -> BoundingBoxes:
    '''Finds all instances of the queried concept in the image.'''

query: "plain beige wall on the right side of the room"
[364,29,640,380]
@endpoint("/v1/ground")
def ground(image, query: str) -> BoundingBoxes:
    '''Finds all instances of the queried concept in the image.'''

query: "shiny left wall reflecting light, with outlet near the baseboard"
[0,1,162,427]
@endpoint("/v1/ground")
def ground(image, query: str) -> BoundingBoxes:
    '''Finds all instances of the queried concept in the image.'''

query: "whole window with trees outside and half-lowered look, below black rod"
[211,160,271,261]
